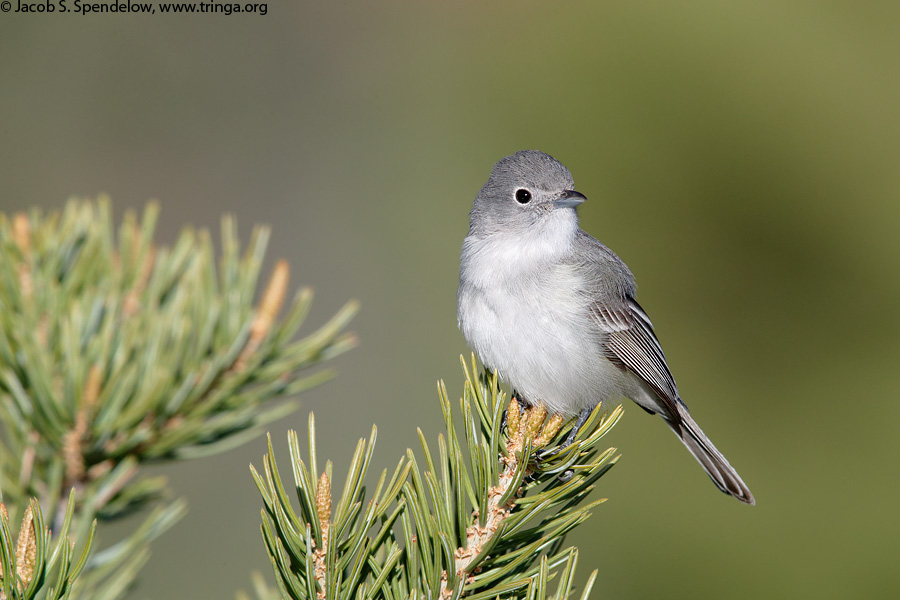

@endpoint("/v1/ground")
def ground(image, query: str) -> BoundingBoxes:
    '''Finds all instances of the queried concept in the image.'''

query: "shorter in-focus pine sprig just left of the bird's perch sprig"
[251,413,410,599]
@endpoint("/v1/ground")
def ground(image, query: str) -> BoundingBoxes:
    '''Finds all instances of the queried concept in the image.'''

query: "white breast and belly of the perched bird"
[459,213,625,414]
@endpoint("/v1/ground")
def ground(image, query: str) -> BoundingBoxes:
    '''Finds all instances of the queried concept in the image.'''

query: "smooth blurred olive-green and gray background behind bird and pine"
[0,0,900,600]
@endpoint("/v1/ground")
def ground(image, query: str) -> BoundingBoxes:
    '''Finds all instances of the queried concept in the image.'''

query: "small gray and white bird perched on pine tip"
[457,150,755,504]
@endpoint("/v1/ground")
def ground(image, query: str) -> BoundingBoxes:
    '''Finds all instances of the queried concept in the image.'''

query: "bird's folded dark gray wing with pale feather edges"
[591,294,679,415]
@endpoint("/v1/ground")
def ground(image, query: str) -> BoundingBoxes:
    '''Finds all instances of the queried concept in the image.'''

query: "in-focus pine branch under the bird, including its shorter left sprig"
[251,357,622,600]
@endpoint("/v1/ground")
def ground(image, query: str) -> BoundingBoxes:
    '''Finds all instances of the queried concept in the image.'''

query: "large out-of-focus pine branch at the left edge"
[0,200,357,600]
